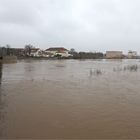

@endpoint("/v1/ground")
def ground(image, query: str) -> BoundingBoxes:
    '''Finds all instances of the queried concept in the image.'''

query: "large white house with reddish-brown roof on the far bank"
[45,47,71,58]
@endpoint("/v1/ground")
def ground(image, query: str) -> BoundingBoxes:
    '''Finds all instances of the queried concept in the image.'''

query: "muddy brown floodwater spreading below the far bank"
[0,60,140,139]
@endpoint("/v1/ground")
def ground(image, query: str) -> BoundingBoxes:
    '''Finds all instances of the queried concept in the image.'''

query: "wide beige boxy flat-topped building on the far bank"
[106,51,123,59]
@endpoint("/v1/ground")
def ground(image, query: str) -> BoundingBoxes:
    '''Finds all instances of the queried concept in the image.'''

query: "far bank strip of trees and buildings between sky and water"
[0,44,140,63]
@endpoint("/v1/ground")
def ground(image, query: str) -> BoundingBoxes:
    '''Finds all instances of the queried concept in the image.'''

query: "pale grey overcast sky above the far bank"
[0,0,140,53]
